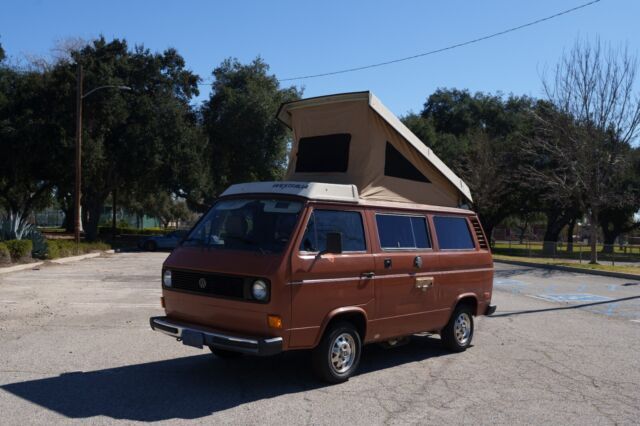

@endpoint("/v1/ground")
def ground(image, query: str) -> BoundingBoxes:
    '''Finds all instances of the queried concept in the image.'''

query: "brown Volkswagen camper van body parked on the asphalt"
[150,182,495,382]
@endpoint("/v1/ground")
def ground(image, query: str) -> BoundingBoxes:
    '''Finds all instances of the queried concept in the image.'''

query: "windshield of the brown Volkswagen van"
[183,199,302,253]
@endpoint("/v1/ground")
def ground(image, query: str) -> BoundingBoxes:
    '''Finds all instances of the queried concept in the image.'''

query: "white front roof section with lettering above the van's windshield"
[222,181,359,203]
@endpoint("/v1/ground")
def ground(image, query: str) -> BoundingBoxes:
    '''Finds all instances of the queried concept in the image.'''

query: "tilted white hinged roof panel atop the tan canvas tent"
[277,91,473,201]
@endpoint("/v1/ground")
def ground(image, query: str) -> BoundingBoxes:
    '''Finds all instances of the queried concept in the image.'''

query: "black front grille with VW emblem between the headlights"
[171,270,245,299]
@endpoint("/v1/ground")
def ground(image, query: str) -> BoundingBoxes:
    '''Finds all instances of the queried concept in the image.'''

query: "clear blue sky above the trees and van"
[0,0,640,115]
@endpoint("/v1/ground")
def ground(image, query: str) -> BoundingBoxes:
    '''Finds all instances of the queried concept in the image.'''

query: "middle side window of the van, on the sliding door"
[376,214,431,250]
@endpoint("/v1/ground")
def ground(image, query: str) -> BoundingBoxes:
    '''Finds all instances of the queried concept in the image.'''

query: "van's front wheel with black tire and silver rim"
[312,321,362,383]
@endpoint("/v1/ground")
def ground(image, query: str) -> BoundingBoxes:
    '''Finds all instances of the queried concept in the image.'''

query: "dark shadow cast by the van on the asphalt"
[1,337,447,421]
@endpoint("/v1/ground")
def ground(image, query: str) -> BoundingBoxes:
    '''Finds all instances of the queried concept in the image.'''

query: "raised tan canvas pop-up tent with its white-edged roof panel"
[278,92,472,207]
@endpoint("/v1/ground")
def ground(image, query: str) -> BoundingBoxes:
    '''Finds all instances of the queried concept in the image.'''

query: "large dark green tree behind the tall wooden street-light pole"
[53,37,205,240]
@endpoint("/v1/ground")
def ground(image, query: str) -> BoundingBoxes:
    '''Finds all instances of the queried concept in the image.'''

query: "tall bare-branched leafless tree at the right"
[538,40,640,263]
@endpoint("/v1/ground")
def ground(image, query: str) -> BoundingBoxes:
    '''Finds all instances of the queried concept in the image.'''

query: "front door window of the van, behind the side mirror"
[300,210,367,252]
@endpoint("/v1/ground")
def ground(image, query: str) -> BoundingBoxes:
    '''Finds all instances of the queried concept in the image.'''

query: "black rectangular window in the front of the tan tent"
[296,133,351,173]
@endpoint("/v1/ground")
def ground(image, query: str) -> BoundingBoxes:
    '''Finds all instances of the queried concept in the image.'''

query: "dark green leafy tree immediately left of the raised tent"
[202,58,301,198]
